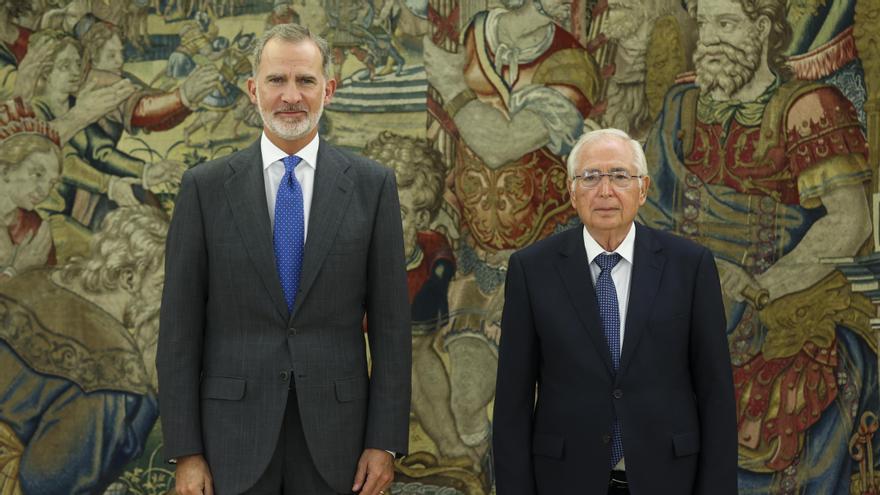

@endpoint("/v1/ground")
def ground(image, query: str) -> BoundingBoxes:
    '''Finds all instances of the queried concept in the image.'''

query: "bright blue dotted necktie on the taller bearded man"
[273,155,305,312]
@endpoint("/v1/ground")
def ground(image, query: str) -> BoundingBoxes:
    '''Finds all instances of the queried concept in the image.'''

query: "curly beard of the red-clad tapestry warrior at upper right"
[694,30,763,99]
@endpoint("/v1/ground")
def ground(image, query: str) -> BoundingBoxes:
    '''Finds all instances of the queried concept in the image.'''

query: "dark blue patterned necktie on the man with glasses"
[594,253,623,468]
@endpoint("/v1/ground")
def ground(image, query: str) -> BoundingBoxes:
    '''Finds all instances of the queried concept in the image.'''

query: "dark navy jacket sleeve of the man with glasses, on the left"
[492,254,540,495]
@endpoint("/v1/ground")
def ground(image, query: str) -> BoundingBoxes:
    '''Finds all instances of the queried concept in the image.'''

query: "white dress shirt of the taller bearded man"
[260,132,320,243]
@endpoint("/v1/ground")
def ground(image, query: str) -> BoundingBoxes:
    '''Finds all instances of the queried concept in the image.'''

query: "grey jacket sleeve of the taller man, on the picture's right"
[364,169,412,455]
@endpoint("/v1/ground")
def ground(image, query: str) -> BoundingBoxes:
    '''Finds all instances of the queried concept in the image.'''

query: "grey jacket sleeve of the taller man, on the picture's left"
[156,171,208,459]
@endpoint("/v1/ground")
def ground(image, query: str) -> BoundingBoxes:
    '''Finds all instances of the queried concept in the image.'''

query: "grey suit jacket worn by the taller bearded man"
[156,141,411,494]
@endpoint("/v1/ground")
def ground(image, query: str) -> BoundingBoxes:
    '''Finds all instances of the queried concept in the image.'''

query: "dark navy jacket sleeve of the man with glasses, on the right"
[690,249,737,495]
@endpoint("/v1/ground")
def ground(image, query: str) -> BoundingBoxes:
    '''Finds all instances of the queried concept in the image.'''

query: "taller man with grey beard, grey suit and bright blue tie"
[156,24,411,495]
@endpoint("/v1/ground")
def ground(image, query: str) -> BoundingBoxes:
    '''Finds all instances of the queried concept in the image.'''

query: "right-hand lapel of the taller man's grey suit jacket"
[291,139,354,317]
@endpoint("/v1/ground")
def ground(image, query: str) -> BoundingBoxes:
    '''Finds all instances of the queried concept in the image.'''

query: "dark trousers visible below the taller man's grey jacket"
[244,389,348,495]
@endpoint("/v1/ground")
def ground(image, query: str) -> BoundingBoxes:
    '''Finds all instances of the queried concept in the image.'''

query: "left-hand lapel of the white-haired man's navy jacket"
[556,228,613,375]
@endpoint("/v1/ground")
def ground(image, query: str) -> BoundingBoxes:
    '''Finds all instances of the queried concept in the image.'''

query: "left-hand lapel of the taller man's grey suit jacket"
[224,140,287,319]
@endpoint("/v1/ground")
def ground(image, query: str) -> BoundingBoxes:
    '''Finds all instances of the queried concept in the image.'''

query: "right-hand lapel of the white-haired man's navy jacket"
[620,223,666,373]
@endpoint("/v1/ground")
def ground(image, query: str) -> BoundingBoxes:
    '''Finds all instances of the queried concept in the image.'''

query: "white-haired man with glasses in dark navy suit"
[493,129,737,495]
